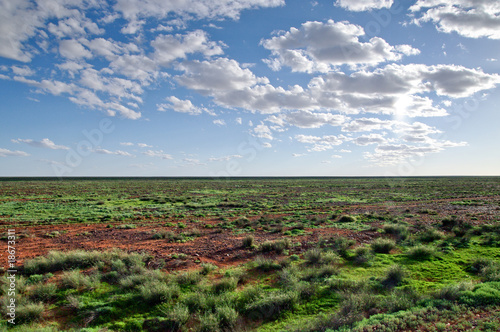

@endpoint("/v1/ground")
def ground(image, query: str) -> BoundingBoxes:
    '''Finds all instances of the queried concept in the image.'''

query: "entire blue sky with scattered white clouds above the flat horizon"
[0,0,500,177]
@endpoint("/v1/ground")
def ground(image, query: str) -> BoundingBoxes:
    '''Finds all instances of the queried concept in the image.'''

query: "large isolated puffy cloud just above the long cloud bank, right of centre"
[261,20,419,73]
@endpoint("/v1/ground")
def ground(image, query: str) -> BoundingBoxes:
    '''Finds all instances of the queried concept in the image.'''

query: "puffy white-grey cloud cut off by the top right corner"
[410,0,500,39]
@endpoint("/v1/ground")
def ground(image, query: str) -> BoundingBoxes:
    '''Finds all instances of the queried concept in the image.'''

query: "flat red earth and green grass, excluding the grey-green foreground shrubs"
[0,177,500,331]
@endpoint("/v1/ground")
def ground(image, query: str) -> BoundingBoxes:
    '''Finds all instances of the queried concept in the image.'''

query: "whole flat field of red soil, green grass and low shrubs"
[0,177,500,331]
